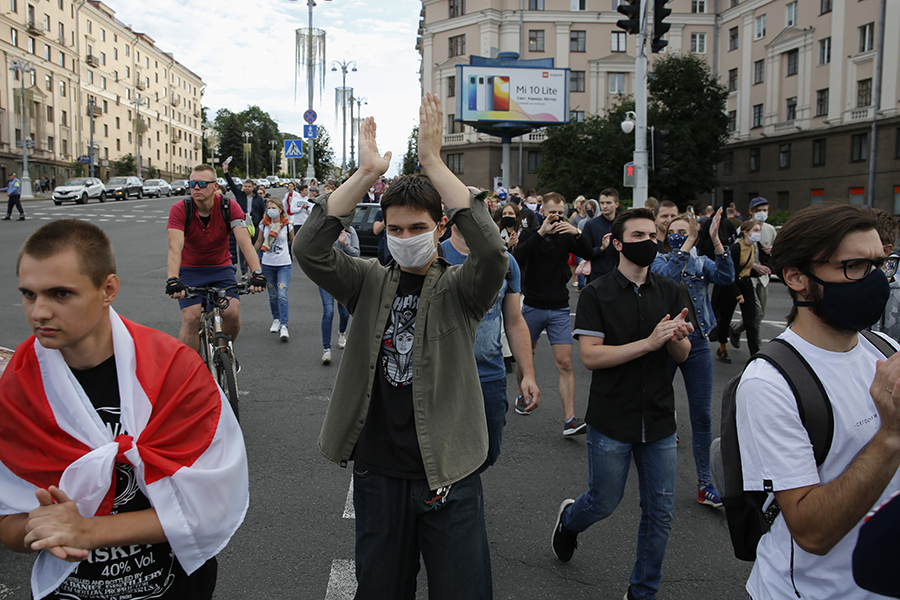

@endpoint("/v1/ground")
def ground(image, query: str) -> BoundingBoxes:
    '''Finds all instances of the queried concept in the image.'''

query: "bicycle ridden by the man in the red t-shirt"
[184,281,250,420]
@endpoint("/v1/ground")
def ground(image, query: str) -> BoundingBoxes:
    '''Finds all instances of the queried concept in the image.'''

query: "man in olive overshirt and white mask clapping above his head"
[293,93,508,600]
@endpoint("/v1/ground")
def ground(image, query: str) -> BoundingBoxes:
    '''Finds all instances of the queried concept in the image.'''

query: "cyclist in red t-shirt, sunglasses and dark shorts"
[166,164,266,350]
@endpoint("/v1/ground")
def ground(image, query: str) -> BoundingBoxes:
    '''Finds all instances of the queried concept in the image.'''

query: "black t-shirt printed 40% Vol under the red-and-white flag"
[47,356,217,600]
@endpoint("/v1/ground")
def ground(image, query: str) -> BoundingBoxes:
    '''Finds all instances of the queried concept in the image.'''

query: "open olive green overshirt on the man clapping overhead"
[293,195,508,490]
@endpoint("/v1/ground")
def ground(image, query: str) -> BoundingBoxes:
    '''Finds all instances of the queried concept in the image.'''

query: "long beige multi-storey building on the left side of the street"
[0,0,204,182]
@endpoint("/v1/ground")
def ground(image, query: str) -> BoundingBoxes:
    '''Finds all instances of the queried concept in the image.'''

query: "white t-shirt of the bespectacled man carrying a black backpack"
[736,329,900,600]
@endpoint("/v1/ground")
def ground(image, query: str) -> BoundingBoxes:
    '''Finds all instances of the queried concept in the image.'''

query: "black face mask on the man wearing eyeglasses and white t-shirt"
[794,269,891,331]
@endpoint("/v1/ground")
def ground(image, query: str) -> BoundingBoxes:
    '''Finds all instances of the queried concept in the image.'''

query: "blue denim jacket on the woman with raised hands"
[650,250,734,337]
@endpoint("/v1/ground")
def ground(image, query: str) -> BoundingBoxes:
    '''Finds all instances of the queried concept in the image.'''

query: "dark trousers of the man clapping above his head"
[353,465,492,600]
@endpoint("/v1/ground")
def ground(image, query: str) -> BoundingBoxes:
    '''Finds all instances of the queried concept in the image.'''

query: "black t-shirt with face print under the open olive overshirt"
[353,272,425,479]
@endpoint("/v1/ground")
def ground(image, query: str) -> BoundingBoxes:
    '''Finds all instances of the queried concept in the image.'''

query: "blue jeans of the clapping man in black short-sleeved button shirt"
[563,426,678,600]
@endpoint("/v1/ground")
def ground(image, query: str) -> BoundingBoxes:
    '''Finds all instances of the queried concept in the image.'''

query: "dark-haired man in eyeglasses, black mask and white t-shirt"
[736,203,900,600]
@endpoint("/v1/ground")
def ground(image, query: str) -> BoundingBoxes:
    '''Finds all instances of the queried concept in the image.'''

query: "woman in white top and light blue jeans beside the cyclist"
[256,198,294,342]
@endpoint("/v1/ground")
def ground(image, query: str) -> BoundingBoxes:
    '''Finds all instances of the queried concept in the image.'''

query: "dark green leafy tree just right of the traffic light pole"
[648,54,728,208]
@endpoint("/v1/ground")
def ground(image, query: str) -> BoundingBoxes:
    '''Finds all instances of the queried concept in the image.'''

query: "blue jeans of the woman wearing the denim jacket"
[669,331,712,487]
